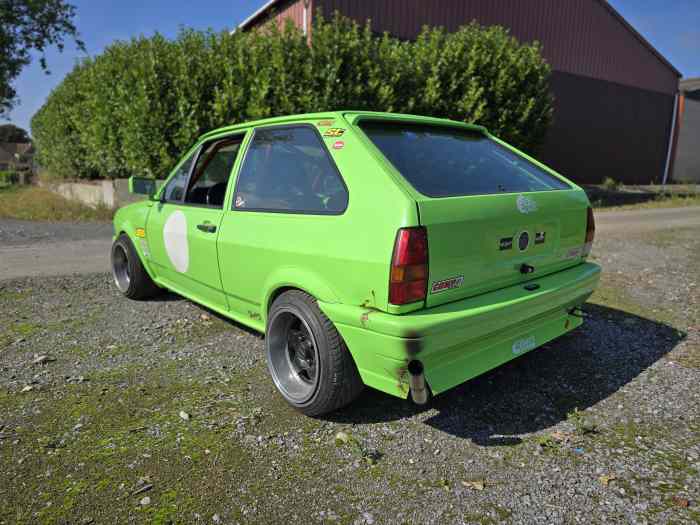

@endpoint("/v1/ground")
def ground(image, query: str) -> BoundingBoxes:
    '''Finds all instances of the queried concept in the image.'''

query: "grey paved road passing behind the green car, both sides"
[0,207,700,279]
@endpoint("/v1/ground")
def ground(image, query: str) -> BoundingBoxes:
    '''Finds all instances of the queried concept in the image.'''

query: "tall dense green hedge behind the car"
[32,16,552,178]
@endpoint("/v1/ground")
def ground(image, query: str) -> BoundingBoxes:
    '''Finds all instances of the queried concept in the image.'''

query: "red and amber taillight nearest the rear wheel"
[389,227,428,304]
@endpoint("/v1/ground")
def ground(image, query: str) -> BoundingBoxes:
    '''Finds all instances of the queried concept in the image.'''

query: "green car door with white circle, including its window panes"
[146,134,244,309]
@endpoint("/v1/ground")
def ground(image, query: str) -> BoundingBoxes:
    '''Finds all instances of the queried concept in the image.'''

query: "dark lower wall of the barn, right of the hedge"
[537,71,674,184]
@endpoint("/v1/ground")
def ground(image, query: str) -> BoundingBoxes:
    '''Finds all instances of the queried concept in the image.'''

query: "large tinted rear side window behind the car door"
[233,126,348,214]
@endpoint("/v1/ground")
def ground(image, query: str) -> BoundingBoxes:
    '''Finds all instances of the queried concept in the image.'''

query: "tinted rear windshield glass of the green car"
[360,121,570,197]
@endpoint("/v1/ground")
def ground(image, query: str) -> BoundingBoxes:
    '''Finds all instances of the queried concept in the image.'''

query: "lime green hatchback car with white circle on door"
[111,111,600,415]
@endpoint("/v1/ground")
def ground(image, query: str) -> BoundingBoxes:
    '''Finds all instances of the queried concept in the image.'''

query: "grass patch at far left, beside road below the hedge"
[0,186,114,222]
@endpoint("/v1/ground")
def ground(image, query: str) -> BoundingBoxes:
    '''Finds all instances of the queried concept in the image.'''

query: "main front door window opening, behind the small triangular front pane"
[185,137,242,208]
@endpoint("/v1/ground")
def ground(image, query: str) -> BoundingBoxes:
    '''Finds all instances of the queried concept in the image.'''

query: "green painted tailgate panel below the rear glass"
[418,191,587,306]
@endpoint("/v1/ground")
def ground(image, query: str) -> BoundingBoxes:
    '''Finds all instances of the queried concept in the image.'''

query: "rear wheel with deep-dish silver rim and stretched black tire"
[265,290,364,416]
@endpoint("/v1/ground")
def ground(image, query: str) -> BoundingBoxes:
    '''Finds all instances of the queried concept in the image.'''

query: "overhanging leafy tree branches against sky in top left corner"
[0,0,85,116]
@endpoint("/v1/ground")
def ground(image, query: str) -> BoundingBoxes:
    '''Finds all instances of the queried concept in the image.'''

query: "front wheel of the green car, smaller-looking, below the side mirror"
[111,233,161,300]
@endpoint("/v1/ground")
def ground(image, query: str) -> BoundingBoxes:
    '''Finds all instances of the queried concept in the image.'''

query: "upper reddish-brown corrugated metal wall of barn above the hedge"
[316,0,678,94]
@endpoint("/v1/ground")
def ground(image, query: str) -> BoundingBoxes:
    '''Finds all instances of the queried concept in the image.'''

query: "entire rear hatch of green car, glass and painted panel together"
[359,120,588,307]
